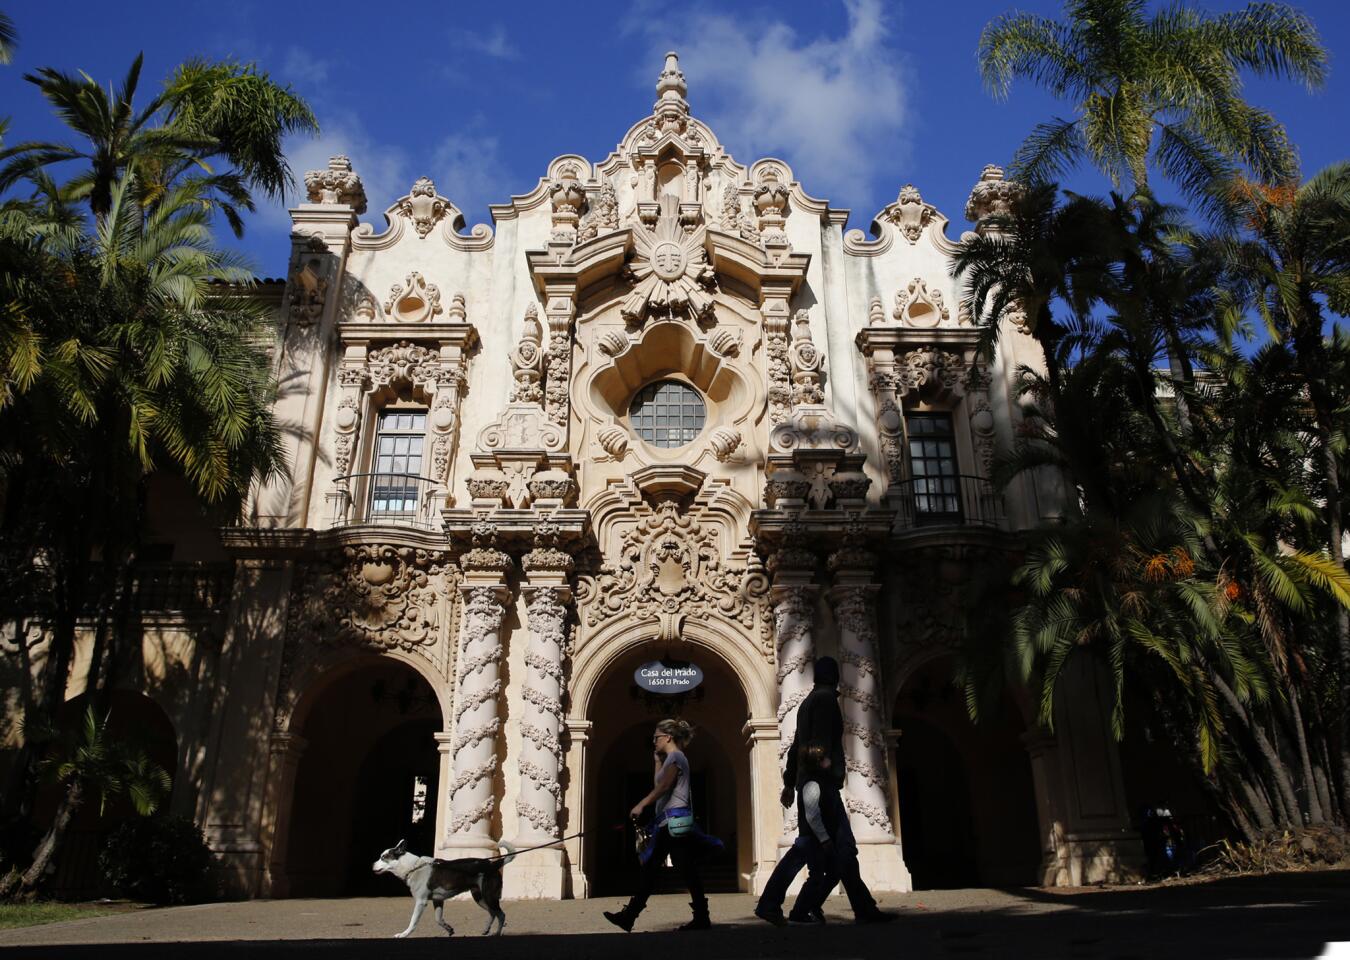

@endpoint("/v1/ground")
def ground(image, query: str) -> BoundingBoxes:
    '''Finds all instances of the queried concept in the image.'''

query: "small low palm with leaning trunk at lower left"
[0,706,173,898]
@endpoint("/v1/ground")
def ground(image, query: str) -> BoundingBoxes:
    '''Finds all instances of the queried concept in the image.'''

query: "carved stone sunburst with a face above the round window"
[620,196,716,325]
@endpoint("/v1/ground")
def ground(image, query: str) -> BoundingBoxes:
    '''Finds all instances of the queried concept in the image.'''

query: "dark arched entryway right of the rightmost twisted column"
[892,658,1041,890]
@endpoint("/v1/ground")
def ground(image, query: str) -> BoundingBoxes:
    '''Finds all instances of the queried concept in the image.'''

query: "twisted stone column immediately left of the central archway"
[506,517,572,899]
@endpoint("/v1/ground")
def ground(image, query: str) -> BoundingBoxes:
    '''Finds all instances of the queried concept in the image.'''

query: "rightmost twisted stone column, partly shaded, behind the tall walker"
[829,523,913,891]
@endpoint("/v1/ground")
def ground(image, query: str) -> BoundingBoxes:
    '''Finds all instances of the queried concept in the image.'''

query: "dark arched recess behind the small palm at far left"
[30,690,180,899]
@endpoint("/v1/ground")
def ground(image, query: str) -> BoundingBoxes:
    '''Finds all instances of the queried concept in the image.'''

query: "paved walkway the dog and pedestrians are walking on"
[0,871,1350,960]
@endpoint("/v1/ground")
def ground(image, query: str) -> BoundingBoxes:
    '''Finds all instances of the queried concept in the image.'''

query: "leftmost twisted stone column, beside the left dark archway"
[444,521,512,856]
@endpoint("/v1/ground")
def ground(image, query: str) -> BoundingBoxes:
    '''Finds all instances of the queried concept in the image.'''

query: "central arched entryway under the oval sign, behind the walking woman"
[583,647,755,897]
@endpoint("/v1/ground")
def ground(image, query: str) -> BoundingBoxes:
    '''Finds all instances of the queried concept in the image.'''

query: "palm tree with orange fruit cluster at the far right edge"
[1211,162,1350,818]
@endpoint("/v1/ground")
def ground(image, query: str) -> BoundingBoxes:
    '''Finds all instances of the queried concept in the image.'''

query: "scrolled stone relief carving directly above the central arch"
[586,501,768,643]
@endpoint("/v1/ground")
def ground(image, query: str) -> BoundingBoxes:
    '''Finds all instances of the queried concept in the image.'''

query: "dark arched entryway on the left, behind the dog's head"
[281,658,443,897]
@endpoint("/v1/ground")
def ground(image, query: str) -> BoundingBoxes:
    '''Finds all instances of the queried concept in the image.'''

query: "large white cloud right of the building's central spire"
[629,0,910,209]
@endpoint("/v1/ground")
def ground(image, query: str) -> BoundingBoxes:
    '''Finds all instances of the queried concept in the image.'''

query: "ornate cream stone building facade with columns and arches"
[10,54,1138,898]
